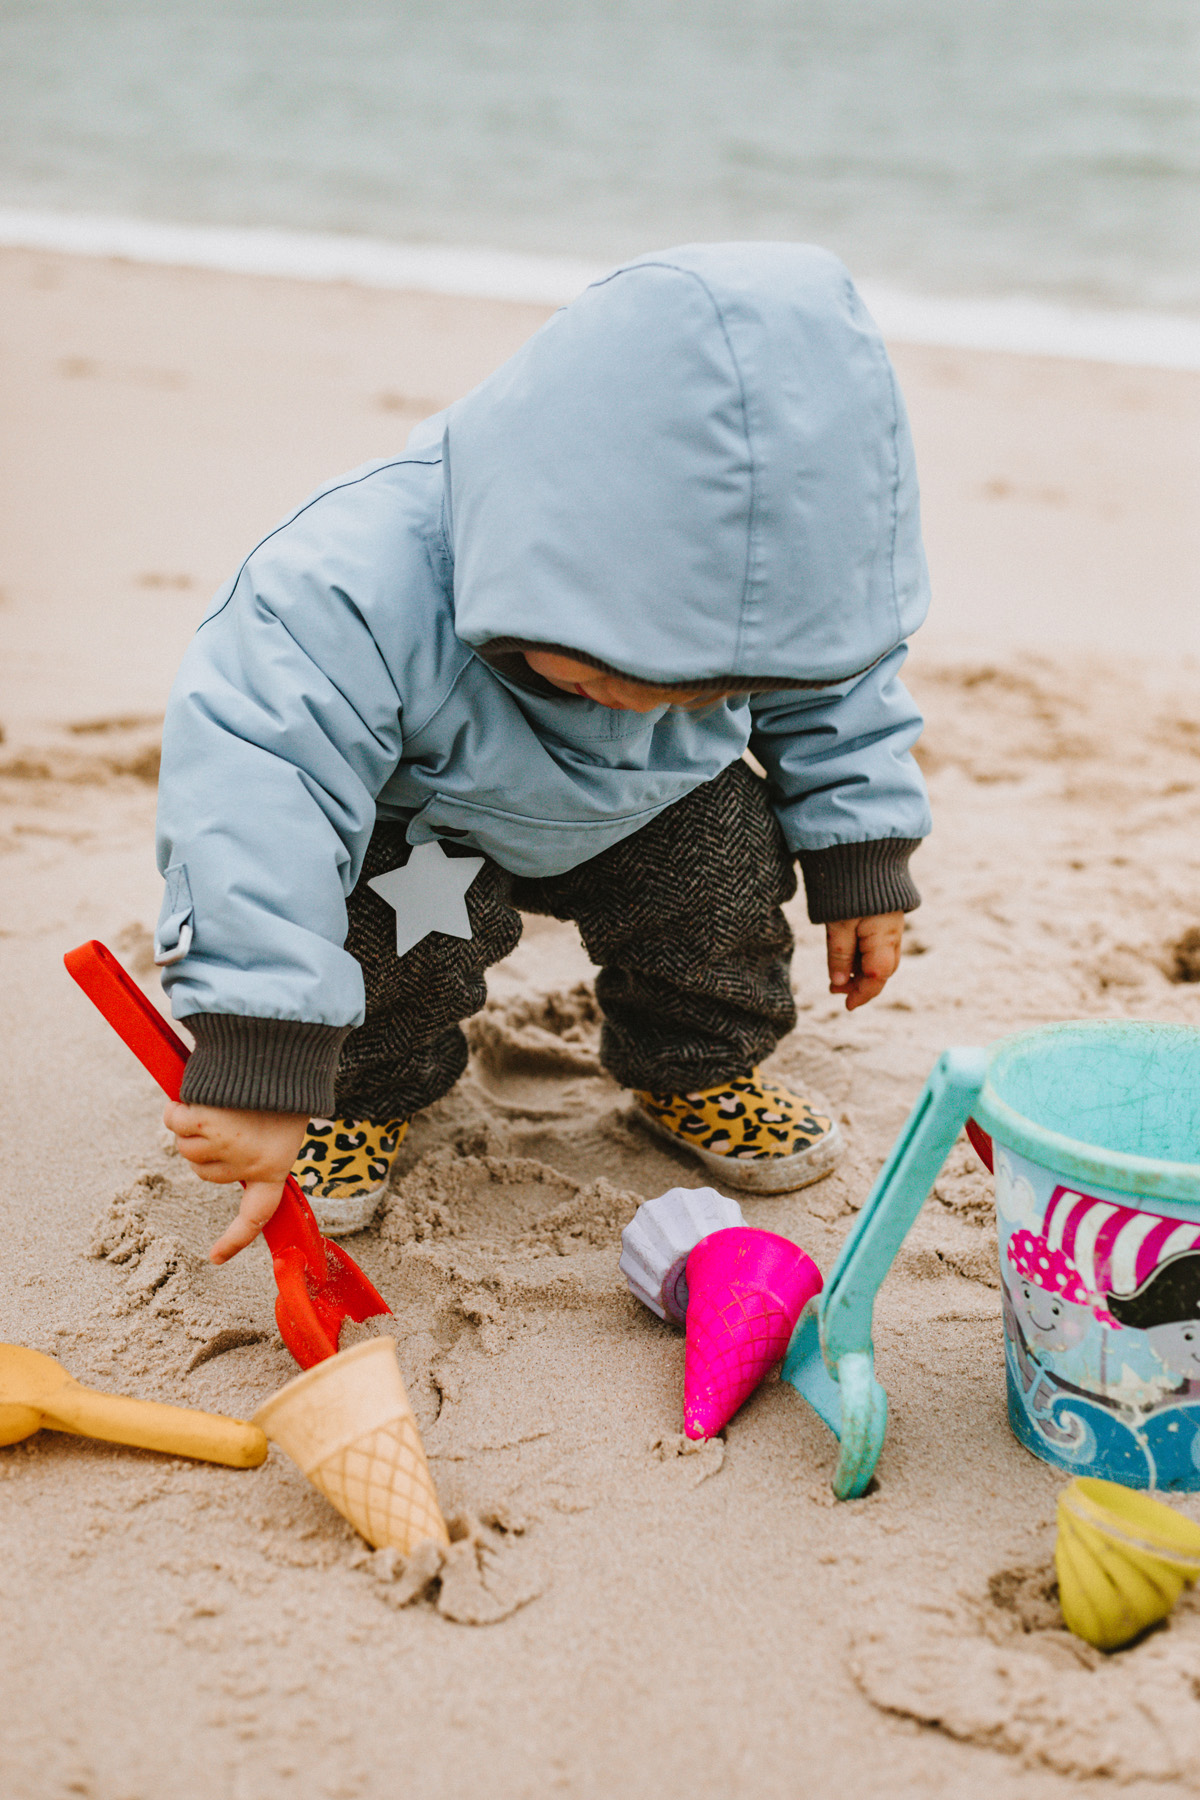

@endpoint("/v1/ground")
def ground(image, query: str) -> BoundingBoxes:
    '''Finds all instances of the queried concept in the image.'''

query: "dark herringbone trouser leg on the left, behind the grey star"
[336,823,522,1121]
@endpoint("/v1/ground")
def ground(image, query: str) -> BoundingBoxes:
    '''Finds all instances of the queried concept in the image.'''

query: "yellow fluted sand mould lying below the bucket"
[1054,1476,1200,1651]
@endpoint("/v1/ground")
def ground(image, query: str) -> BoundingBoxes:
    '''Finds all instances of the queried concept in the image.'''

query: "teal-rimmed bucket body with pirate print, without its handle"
[975,1021,1200,1490]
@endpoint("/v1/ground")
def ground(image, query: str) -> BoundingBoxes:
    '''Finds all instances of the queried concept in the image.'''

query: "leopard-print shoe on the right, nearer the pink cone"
[633,1069,846,1193]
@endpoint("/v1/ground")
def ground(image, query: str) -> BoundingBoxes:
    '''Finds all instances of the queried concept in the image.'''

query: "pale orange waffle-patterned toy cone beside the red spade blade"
[254,1337,450,1555]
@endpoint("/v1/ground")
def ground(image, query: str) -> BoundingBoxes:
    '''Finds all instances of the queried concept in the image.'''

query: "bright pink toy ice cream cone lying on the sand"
[684,1226,822,1438]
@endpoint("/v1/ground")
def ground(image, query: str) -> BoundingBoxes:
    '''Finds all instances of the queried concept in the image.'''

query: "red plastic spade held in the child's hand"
[63,938,392,1368]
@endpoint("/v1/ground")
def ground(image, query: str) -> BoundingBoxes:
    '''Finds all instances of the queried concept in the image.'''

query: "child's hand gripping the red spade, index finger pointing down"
[162,1100,308,1262]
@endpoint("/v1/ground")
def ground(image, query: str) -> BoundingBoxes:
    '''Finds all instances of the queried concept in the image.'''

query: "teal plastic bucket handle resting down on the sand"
[783,1049,988,1499]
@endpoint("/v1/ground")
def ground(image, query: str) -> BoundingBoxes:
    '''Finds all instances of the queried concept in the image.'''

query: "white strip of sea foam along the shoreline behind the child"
[0,207,1200,369]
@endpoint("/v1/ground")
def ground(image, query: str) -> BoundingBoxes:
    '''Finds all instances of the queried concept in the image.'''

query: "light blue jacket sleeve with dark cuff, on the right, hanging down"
[750,644,930,923]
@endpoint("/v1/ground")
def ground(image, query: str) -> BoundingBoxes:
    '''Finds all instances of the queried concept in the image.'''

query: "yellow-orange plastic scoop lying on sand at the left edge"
[0,1345,266,1469]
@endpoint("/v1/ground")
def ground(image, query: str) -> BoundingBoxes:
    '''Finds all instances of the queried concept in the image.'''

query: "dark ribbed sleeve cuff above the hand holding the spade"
[180,1013,351,1118]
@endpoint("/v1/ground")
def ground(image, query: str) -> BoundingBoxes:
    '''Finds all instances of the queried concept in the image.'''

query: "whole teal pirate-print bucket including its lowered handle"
[783,1021,1200,1498]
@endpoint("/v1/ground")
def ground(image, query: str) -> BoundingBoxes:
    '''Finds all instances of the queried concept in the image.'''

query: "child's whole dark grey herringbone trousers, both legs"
[336,761,795,1120]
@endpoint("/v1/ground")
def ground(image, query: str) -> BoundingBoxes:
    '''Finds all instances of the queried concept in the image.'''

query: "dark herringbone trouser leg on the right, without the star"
[511,761,795,1093]
